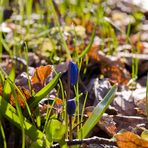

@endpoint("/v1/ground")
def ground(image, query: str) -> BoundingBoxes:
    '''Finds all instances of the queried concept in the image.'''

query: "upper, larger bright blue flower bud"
[69,61,78,86]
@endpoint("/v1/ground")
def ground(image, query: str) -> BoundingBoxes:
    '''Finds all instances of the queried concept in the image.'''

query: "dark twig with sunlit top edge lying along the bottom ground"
[52,136,117,148]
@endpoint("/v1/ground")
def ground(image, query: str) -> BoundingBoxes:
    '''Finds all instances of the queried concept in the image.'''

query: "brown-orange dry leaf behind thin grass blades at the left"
[9,86,31,108]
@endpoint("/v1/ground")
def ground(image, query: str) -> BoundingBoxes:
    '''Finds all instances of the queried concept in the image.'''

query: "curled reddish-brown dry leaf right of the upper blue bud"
[88,46,130,84]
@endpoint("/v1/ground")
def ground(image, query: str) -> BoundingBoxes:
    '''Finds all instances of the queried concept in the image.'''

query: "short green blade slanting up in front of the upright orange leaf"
[29,74,60,107]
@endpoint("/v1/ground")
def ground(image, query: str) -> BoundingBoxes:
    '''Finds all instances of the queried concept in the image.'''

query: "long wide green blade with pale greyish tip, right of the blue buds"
[78,85,117,138]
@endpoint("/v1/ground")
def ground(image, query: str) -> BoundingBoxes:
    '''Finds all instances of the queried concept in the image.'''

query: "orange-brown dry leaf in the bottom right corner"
[115,131,148,148]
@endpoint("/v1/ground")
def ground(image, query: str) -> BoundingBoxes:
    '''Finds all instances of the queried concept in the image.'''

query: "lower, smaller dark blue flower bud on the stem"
[66,99,76,116]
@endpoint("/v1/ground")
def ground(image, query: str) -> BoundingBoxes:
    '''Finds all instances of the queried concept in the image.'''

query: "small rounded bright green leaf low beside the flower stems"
[45,119,66,142]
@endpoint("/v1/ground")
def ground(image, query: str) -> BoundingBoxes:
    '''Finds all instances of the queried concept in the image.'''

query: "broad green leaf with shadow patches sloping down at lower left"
[0,96,47,141]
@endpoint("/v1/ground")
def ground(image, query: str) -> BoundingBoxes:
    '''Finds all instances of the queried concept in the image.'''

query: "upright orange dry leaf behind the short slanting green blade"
[31,65,52,90]
